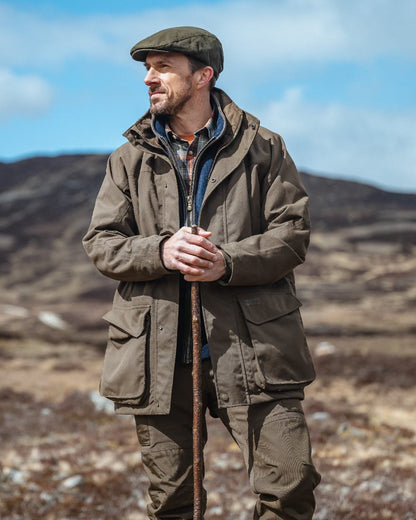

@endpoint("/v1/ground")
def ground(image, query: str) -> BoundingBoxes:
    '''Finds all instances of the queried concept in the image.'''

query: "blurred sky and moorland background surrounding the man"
[0,0,416,520]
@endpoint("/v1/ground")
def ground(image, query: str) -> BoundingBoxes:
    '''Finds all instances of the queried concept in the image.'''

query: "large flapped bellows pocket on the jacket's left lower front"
[100,305,150,404]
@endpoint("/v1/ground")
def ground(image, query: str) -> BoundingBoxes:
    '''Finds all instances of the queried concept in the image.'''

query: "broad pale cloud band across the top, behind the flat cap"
[0,0,416,66]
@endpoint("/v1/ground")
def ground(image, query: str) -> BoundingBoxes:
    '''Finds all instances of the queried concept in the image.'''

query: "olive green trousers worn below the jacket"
[135,360,320,520]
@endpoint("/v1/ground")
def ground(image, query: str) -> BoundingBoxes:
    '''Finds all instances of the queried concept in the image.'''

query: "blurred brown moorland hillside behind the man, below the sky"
[0,155,416,343]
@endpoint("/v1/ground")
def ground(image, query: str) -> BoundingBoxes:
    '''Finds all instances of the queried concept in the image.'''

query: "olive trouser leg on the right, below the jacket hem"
[218,399,320,520]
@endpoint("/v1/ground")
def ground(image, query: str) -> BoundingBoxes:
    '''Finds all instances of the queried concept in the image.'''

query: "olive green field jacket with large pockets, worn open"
[83,89,315,414]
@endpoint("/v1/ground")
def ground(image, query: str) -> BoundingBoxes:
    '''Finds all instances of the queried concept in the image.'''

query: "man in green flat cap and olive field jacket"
[84,27,319,520]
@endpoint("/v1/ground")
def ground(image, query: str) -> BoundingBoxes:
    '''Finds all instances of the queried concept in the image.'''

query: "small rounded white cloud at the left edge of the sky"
[0,69,52,121]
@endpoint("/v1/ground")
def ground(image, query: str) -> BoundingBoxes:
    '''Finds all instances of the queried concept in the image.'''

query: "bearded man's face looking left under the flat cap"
[144,52,194,116]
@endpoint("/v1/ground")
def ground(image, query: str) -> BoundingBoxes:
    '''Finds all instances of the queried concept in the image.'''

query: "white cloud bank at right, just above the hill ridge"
[262,88,416,191]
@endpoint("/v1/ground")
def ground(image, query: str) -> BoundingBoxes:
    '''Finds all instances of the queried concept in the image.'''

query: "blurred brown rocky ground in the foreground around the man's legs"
[0,335,416,520]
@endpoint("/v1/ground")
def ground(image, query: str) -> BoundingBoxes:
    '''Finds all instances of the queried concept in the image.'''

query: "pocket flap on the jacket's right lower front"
[238,292,301,325]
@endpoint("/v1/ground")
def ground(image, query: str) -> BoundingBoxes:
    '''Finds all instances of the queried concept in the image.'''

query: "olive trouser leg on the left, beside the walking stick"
[135,366,207,520]
